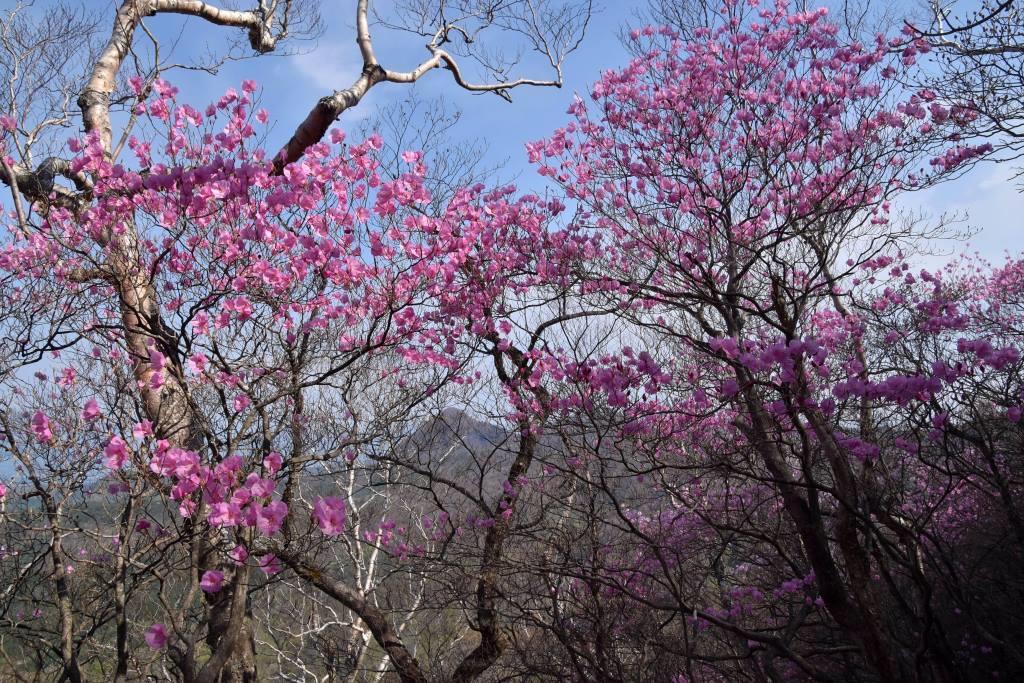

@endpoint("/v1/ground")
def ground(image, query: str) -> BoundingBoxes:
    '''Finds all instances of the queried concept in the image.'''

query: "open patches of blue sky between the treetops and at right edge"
[140,0,1024,265]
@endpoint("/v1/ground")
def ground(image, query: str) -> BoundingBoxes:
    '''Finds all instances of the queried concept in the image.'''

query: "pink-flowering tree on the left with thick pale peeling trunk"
[0,1,589,680]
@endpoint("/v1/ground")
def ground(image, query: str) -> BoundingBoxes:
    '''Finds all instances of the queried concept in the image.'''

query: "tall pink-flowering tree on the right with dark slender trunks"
[529,2,1019,680]
